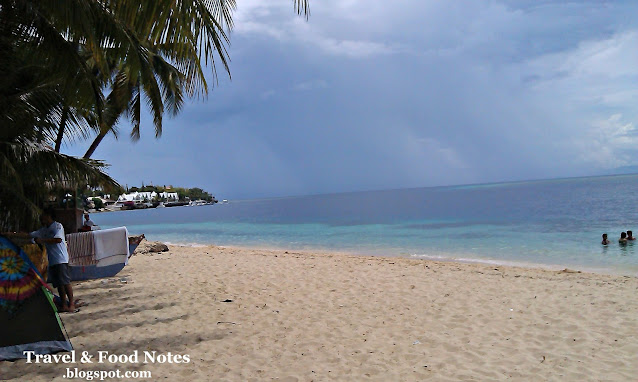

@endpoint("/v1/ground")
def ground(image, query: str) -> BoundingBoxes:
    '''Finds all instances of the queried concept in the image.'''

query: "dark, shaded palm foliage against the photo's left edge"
[0,0,124,230]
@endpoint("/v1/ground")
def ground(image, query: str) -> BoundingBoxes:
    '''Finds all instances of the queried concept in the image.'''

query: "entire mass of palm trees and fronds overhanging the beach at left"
[0,0,309,231]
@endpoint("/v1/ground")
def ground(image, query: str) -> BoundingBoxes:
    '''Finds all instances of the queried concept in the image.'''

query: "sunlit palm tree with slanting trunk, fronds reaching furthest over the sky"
[84,0,310,158]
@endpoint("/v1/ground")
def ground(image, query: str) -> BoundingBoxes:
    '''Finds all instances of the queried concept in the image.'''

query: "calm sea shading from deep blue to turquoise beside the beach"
[92,175,638,275]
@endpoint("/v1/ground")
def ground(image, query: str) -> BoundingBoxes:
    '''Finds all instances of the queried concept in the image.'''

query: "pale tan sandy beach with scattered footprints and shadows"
[0,246,638,381]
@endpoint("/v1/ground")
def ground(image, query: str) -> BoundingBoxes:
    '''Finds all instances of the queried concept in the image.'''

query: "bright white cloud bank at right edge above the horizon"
[510,29,638,170]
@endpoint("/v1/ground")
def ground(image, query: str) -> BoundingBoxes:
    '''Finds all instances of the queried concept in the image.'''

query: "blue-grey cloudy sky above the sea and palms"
[65,0,638,200]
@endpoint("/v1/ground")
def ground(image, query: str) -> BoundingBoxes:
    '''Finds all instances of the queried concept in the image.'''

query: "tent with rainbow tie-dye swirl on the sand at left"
[0,236,73,361]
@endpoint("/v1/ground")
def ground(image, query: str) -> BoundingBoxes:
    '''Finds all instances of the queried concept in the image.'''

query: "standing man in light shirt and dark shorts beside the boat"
[30,210,75,312]
